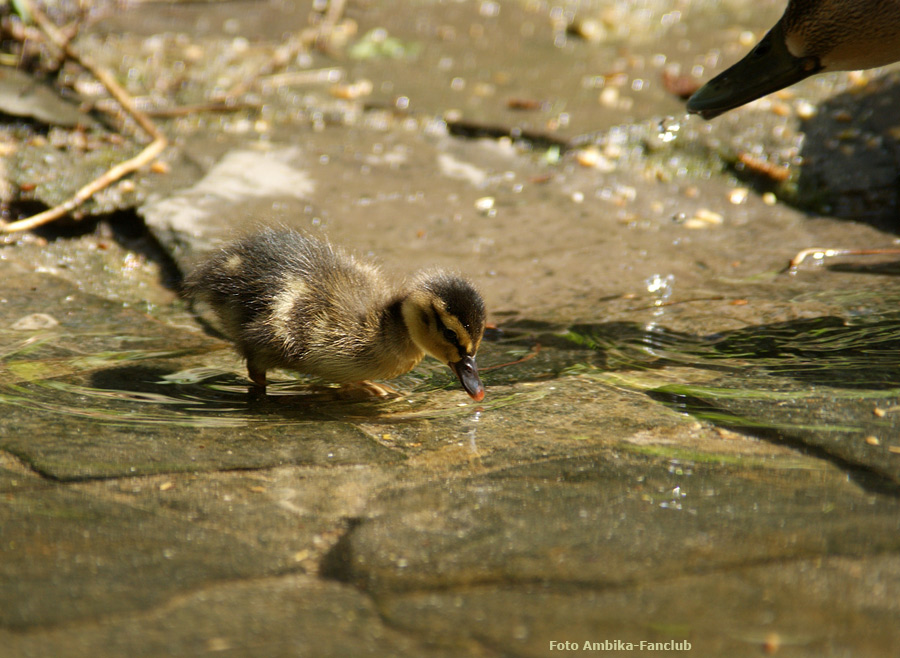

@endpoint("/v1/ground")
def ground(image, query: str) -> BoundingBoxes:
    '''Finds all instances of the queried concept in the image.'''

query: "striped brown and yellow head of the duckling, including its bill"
[401,271,485,402]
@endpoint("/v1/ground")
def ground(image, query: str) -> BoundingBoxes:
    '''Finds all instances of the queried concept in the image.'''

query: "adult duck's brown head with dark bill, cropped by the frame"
[687,0,900,119]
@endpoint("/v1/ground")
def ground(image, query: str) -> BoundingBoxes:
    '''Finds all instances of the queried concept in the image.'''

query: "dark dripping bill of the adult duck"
[687,22,823,119]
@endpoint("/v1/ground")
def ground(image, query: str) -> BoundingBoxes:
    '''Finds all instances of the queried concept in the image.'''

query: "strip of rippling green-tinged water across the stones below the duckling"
[0,312,900,482]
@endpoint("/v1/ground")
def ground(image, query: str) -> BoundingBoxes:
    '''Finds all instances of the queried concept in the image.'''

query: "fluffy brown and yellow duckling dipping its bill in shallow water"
[184,229,485,401]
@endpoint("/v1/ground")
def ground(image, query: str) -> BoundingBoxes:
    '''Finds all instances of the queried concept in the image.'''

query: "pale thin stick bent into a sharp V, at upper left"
[0,0,169,233]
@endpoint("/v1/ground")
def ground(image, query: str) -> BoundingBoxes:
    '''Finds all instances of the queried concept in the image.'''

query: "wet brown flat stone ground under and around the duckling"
[0,0,900,657]
